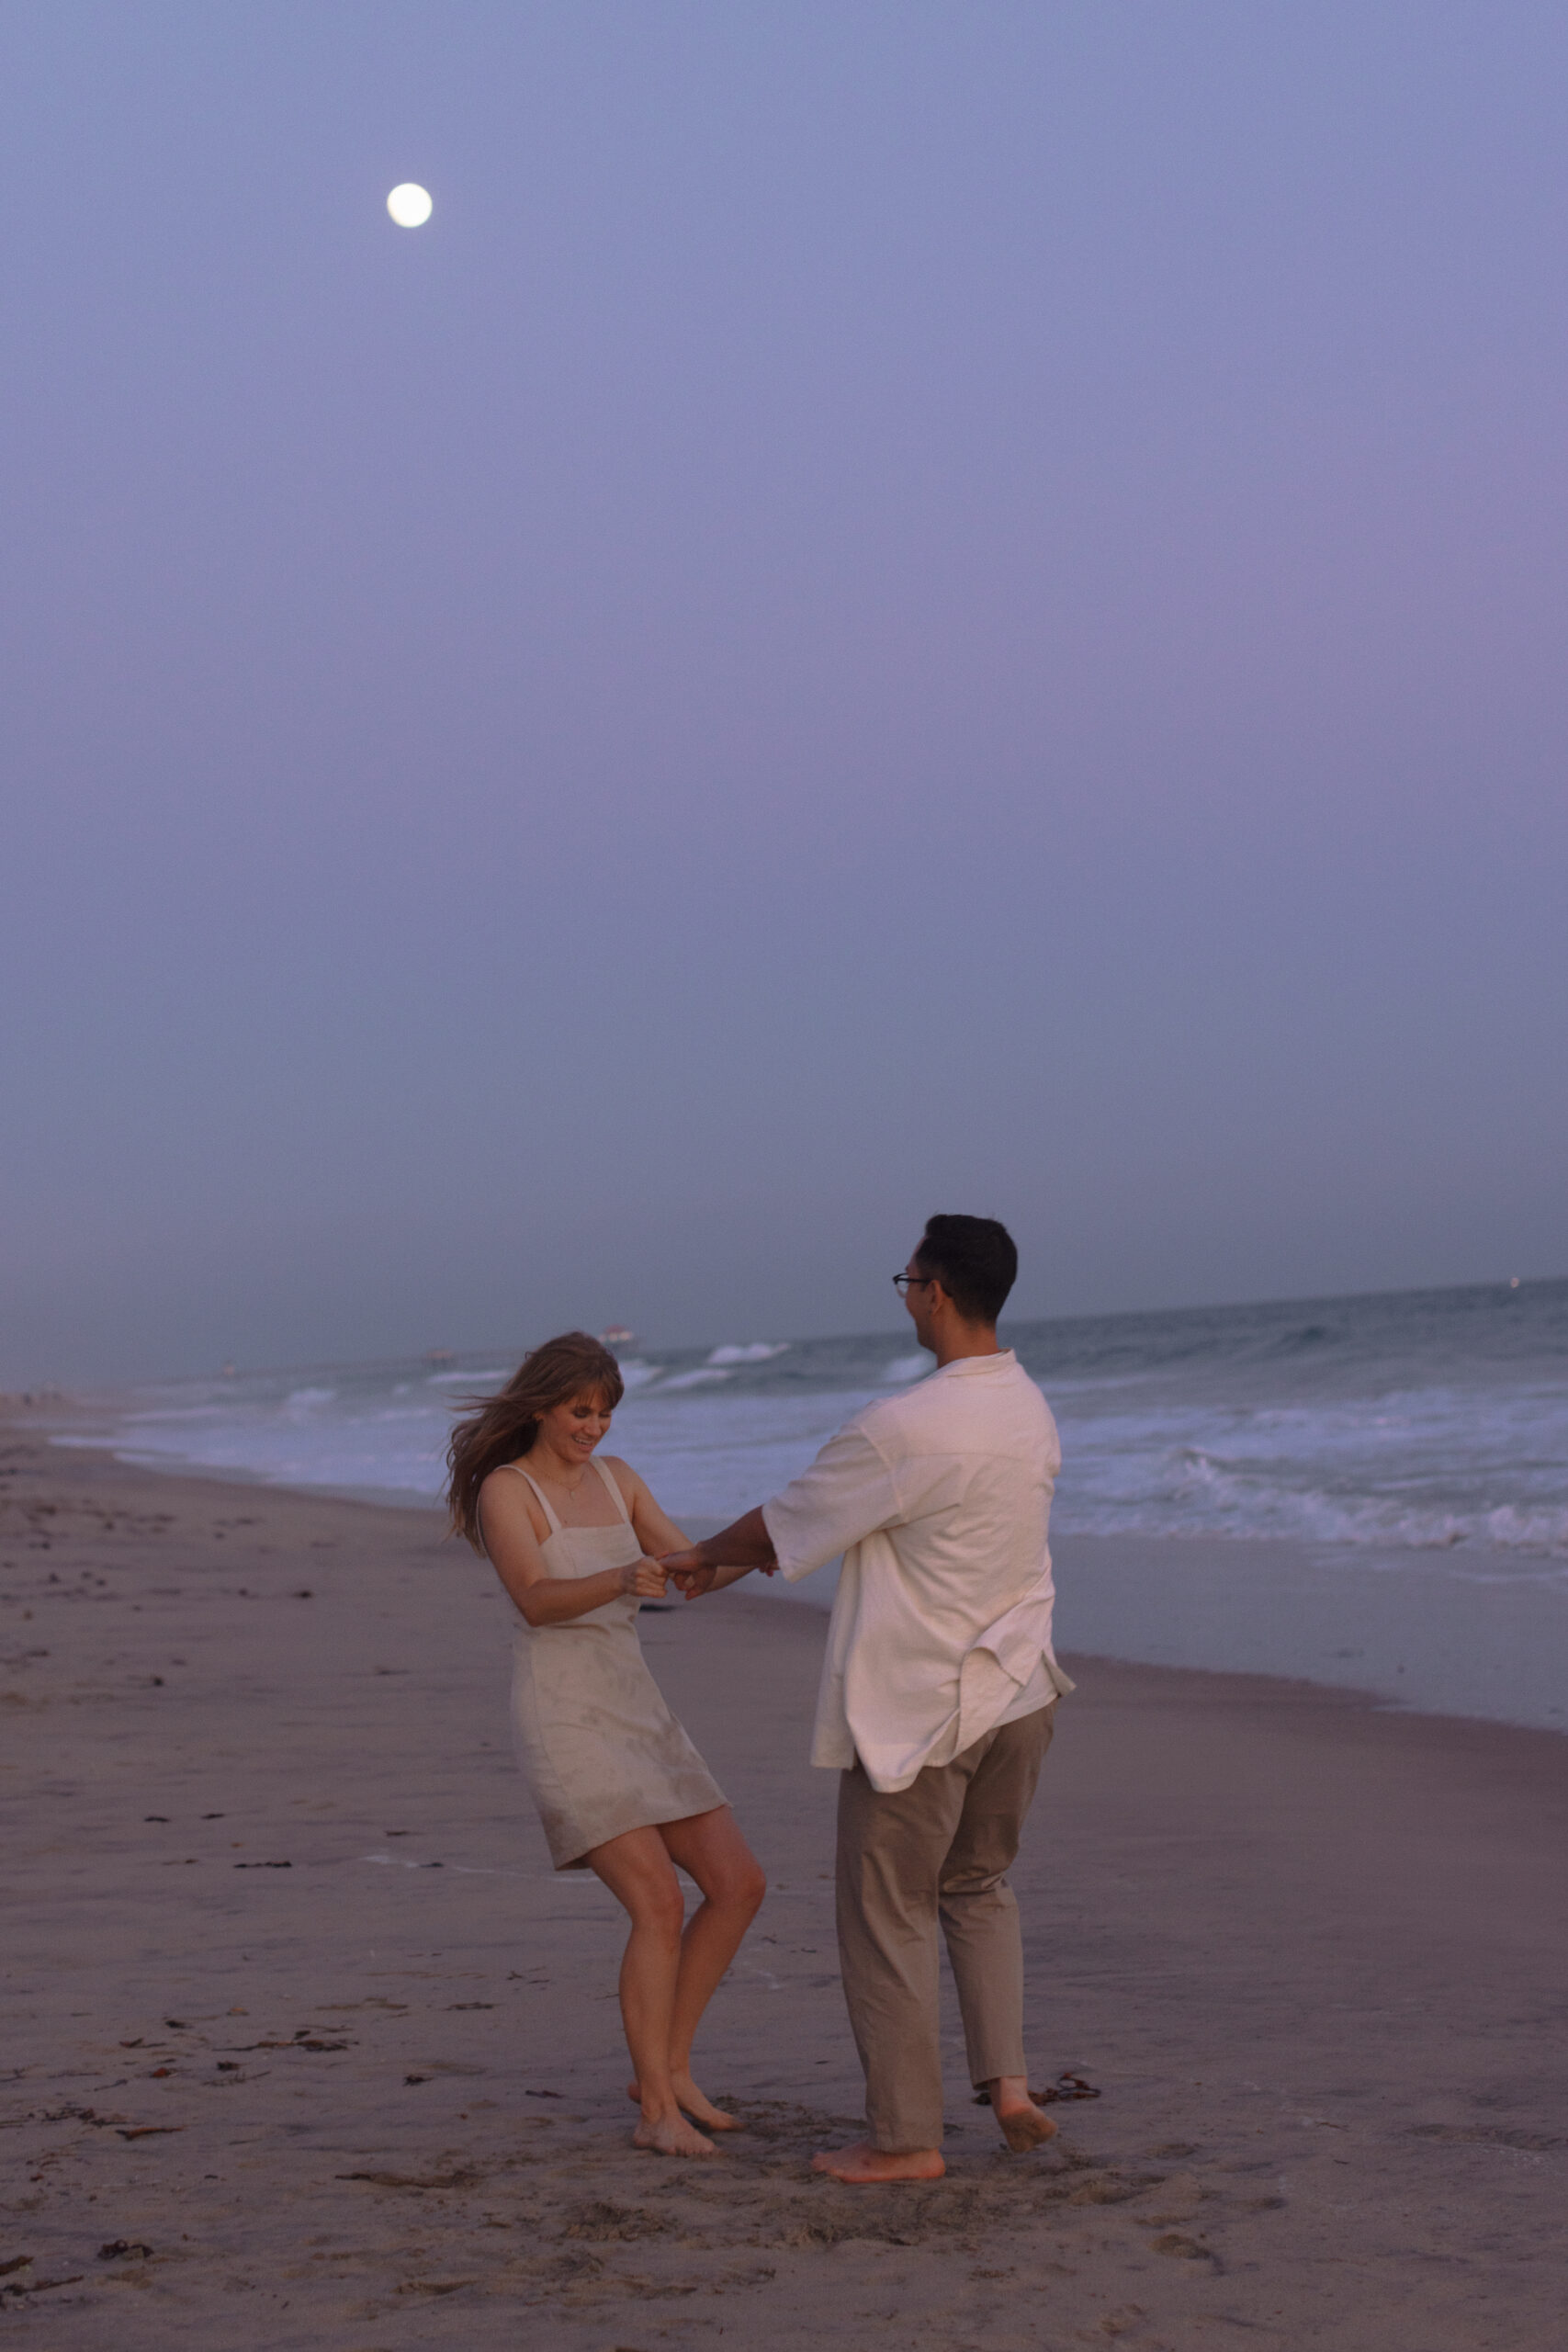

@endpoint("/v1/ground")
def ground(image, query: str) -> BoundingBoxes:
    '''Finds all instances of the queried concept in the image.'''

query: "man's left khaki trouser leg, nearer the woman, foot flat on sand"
[837,1764,964,2150]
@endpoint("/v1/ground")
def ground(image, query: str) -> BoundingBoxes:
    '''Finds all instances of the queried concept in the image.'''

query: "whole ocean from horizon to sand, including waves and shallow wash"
[59,1282,1568,1724]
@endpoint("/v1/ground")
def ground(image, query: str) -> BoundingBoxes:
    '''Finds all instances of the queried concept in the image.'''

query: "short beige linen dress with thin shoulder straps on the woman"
[505,1458,728,1870]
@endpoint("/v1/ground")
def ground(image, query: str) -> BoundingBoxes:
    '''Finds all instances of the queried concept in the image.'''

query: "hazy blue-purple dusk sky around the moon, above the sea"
[0,0,1568,1383]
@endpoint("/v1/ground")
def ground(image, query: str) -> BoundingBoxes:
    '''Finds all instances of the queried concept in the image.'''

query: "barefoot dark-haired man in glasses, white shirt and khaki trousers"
[665,1216,1072,2183]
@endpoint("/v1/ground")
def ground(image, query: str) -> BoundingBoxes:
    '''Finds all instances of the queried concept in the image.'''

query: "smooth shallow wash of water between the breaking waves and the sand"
[24,1399,1568,1736]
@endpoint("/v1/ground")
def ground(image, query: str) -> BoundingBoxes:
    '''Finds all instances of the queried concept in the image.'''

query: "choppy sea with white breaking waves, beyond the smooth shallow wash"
[49,1284,1568,1574]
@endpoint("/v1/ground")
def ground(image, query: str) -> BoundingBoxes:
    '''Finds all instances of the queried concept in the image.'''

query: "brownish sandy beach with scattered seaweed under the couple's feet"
[0,1414,1568,2352]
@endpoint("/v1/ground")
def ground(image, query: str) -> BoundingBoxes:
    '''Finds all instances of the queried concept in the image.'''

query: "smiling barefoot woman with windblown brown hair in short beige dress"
[446,1331,766,2157]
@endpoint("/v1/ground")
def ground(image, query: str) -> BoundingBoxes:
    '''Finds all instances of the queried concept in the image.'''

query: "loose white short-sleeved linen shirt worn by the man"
[761,1348,1072,1794]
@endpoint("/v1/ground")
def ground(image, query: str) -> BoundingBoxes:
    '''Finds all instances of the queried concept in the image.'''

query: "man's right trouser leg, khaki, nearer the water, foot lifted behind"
[938,1708,1055,2086]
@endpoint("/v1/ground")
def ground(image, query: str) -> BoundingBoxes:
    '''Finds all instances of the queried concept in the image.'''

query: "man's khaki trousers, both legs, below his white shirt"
[837,1708,1055,2150]
